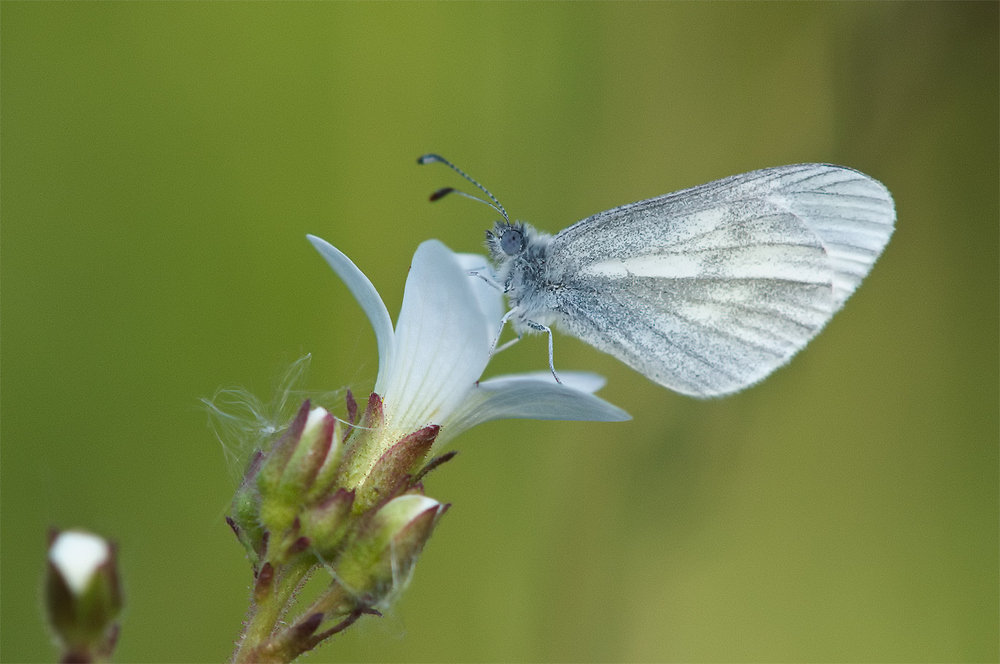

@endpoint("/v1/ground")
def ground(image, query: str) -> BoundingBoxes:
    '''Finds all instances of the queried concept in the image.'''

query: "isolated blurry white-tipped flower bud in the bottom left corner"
[45,530,122,661]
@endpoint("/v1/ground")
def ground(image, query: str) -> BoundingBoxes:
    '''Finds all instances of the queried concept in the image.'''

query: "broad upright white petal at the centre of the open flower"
[375,240,492,429]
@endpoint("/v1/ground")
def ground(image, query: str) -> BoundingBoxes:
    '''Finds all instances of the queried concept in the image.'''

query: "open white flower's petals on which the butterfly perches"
[308,235,630,449]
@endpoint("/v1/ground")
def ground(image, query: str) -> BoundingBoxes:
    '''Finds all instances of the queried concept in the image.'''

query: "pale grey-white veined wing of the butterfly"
[547,164,896,397]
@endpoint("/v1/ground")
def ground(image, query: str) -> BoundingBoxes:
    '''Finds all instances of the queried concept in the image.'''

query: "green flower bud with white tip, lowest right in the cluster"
[336,494,448,604]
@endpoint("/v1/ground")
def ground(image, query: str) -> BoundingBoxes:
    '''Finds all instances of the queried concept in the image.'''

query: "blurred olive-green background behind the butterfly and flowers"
[0,2,1000,662]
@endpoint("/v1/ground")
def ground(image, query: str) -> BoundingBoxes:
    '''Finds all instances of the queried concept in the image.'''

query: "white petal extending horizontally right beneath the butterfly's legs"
[434,372,632,449]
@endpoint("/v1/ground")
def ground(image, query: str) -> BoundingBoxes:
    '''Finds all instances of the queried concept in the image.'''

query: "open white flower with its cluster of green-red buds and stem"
[227,236,628,661]
